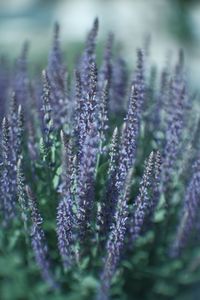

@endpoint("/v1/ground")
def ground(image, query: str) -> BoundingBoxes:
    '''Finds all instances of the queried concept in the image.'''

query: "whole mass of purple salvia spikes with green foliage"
[0,19,200,300]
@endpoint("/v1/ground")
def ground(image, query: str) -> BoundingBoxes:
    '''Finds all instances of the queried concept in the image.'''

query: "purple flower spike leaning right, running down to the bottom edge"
[97,171,132,300]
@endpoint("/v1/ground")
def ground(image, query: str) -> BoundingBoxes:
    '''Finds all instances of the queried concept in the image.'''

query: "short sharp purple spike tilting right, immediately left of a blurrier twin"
[129,152,154,242]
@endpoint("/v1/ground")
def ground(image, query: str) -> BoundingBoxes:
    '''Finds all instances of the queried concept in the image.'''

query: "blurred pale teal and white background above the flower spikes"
[0,0,200,86]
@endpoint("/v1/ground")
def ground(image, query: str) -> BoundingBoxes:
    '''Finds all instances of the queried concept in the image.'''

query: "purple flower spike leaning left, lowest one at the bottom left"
[26,186,57,288]
